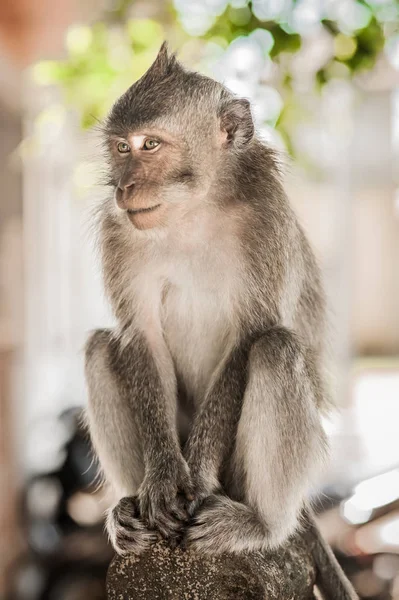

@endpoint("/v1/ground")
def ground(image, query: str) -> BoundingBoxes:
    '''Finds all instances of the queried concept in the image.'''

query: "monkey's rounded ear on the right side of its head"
[219,98,255,149]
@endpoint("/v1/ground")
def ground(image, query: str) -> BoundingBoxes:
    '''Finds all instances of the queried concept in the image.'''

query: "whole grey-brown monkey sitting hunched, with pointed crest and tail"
[85,43,356,600]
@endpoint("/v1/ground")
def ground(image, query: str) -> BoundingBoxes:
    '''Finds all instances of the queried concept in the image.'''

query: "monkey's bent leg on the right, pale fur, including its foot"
[187,327,327,553]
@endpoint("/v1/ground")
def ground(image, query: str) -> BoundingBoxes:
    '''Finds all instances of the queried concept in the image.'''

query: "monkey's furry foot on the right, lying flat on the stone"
[184,495,268,555]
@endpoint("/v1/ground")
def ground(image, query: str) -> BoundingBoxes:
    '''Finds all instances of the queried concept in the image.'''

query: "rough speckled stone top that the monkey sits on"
[107,536,316,600]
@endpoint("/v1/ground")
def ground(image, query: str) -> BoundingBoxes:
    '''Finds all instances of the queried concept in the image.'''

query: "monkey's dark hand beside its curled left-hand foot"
[138,457,194,545]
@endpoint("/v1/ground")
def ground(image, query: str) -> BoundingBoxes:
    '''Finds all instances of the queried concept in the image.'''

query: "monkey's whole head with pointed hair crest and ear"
[105,43,254,229]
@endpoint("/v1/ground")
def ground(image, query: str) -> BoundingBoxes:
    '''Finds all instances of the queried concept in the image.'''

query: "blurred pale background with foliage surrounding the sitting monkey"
[0,0,399,600]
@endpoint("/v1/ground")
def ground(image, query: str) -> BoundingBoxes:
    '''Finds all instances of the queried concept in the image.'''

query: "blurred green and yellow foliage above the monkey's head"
[33,0,399,155]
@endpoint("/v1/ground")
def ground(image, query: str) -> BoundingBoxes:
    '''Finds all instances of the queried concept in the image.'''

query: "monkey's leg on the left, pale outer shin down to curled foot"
[86,330,156,554]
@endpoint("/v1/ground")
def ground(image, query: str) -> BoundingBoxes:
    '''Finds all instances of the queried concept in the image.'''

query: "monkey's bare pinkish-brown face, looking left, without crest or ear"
[108,125,209,229]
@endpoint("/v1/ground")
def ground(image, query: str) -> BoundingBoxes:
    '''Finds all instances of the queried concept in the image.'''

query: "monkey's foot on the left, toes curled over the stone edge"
[107,497,158,556]
